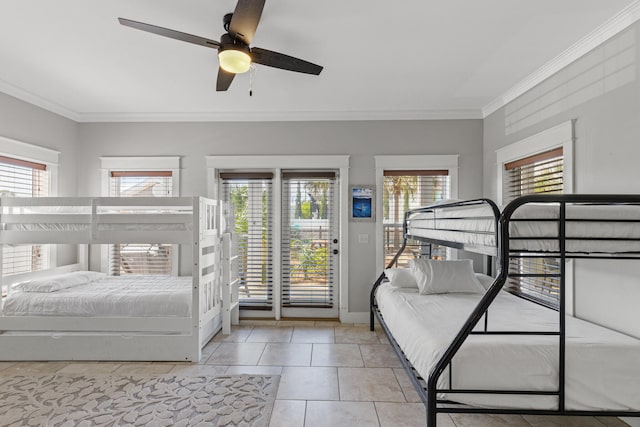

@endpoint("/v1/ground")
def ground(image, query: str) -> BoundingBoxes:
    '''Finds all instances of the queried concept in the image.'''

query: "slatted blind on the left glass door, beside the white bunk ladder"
[220,173,273,309]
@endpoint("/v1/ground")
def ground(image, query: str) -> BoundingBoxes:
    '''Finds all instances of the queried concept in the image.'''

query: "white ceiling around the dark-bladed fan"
[0,0,640,121]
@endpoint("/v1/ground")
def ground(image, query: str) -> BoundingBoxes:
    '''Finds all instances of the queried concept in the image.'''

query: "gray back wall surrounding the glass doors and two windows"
[78,120,482,312]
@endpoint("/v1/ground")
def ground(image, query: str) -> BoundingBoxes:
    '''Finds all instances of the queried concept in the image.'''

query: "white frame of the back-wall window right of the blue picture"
[374,154,460,271]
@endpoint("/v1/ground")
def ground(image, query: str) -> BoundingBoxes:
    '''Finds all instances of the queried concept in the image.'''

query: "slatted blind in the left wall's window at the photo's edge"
[0,156,51,276]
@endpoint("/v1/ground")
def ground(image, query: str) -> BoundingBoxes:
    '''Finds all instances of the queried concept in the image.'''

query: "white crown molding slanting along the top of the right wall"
[482,0,640,118]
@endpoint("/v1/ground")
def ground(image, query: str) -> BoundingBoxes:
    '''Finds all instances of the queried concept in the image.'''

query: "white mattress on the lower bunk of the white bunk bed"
[3,276,192,317]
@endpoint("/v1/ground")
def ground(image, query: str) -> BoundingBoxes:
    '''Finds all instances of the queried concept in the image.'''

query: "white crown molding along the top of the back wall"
[76,110,482,123]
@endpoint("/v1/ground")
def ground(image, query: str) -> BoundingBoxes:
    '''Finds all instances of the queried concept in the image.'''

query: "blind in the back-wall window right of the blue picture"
[382,169,451,267]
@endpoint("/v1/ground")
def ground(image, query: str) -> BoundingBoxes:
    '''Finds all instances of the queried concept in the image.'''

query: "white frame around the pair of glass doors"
[206,155,350,320]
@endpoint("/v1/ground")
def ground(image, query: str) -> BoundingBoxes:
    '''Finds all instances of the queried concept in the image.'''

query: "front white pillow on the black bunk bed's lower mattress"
[412,259,485,295]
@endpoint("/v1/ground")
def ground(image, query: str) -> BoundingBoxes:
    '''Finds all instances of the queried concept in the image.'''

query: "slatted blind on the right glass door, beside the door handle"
[282,172,336,308]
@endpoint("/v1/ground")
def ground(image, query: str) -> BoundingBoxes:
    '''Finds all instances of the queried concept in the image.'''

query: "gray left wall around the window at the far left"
[0,92,78,265]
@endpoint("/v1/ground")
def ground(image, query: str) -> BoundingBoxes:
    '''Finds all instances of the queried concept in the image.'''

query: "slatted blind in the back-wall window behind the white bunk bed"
[109,171,173,276]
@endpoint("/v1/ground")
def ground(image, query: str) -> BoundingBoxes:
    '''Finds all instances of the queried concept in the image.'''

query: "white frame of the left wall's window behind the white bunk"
[0,136,60,268]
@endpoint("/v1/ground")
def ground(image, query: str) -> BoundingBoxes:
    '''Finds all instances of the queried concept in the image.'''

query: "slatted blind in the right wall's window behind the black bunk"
[503,147,564,307]
